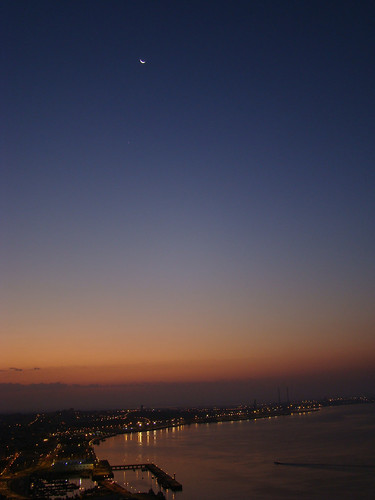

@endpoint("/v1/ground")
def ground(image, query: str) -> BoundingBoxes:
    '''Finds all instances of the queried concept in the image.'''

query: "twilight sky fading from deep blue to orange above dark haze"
[0,0,375,410]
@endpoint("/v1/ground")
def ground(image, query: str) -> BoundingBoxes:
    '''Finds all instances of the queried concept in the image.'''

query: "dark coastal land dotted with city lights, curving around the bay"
[0,397,375,499]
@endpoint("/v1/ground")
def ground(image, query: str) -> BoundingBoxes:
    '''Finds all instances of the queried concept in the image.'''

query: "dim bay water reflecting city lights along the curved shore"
[95,404,375,500]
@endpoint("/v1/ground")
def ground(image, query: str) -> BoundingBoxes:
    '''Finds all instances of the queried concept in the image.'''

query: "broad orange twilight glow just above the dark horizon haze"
[0,294,375,384]
